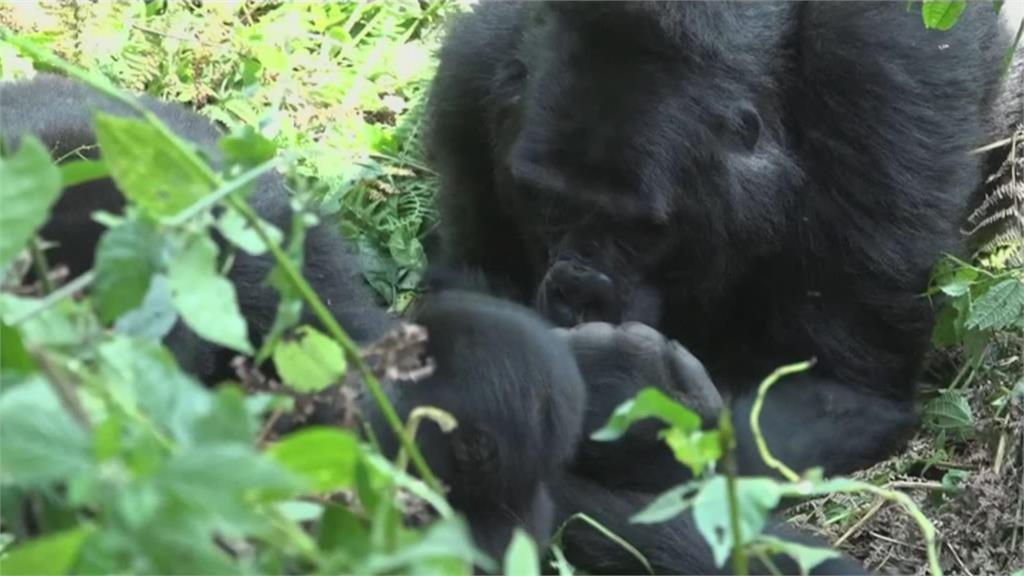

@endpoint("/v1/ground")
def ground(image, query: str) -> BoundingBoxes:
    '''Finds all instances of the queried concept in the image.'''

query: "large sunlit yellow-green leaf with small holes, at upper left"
[96,113,215,217]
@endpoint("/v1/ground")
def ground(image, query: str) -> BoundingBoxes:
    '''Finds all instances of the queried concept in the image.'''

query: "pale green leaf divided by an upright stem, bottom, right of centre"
[693,476,780,568]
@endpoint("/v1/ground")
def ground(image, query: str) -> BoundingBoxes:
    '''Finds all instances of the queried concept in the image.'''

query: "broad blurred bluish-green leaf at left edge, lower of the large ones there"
[0,376,92,485]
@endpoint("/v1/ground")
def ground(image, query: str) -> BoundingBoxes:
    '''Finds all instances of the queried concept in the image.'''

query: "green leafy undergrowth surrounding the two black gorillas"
[0,0,1024,574]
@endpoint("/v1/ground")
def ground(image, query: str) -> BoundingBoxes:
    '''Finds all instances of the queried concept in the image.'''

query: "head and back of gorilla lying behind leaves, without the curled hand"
[0,76,586,558]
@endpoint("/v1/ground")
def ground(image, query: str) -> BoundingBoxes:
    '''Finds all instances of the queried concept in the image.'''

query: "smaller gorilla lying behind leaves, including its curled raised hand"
[0,75,861,574]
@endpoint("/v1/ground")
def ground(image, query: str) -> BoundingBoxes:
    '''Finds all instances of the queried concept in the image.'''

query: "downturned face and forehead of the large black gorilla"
[490,3,774,326]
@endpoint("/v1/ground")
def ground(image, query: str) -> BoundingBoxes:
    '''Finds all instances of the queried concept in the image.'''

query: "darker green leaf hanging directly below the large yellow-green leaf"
[92,220,164,324]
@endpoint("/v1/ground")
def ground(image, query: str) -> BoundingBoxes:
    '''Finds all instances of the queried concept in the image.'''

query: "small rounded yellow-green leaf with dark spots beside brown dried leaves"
[273,326,347,393]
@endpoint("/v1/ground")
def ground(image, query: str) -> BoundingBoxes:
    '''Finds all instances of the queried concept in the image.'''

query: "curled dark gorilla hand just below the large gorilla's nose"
[556,322,722,490]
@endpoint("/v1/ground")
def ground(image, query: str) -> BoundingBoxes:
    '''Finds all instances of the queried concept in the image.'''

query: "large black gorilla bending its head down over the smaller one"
[428,2,1009,571]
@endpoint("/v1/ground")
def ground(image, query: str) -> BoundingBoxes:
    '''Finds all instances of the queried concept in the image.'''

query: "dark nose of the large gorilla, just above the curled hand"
[537,260,621,326]
